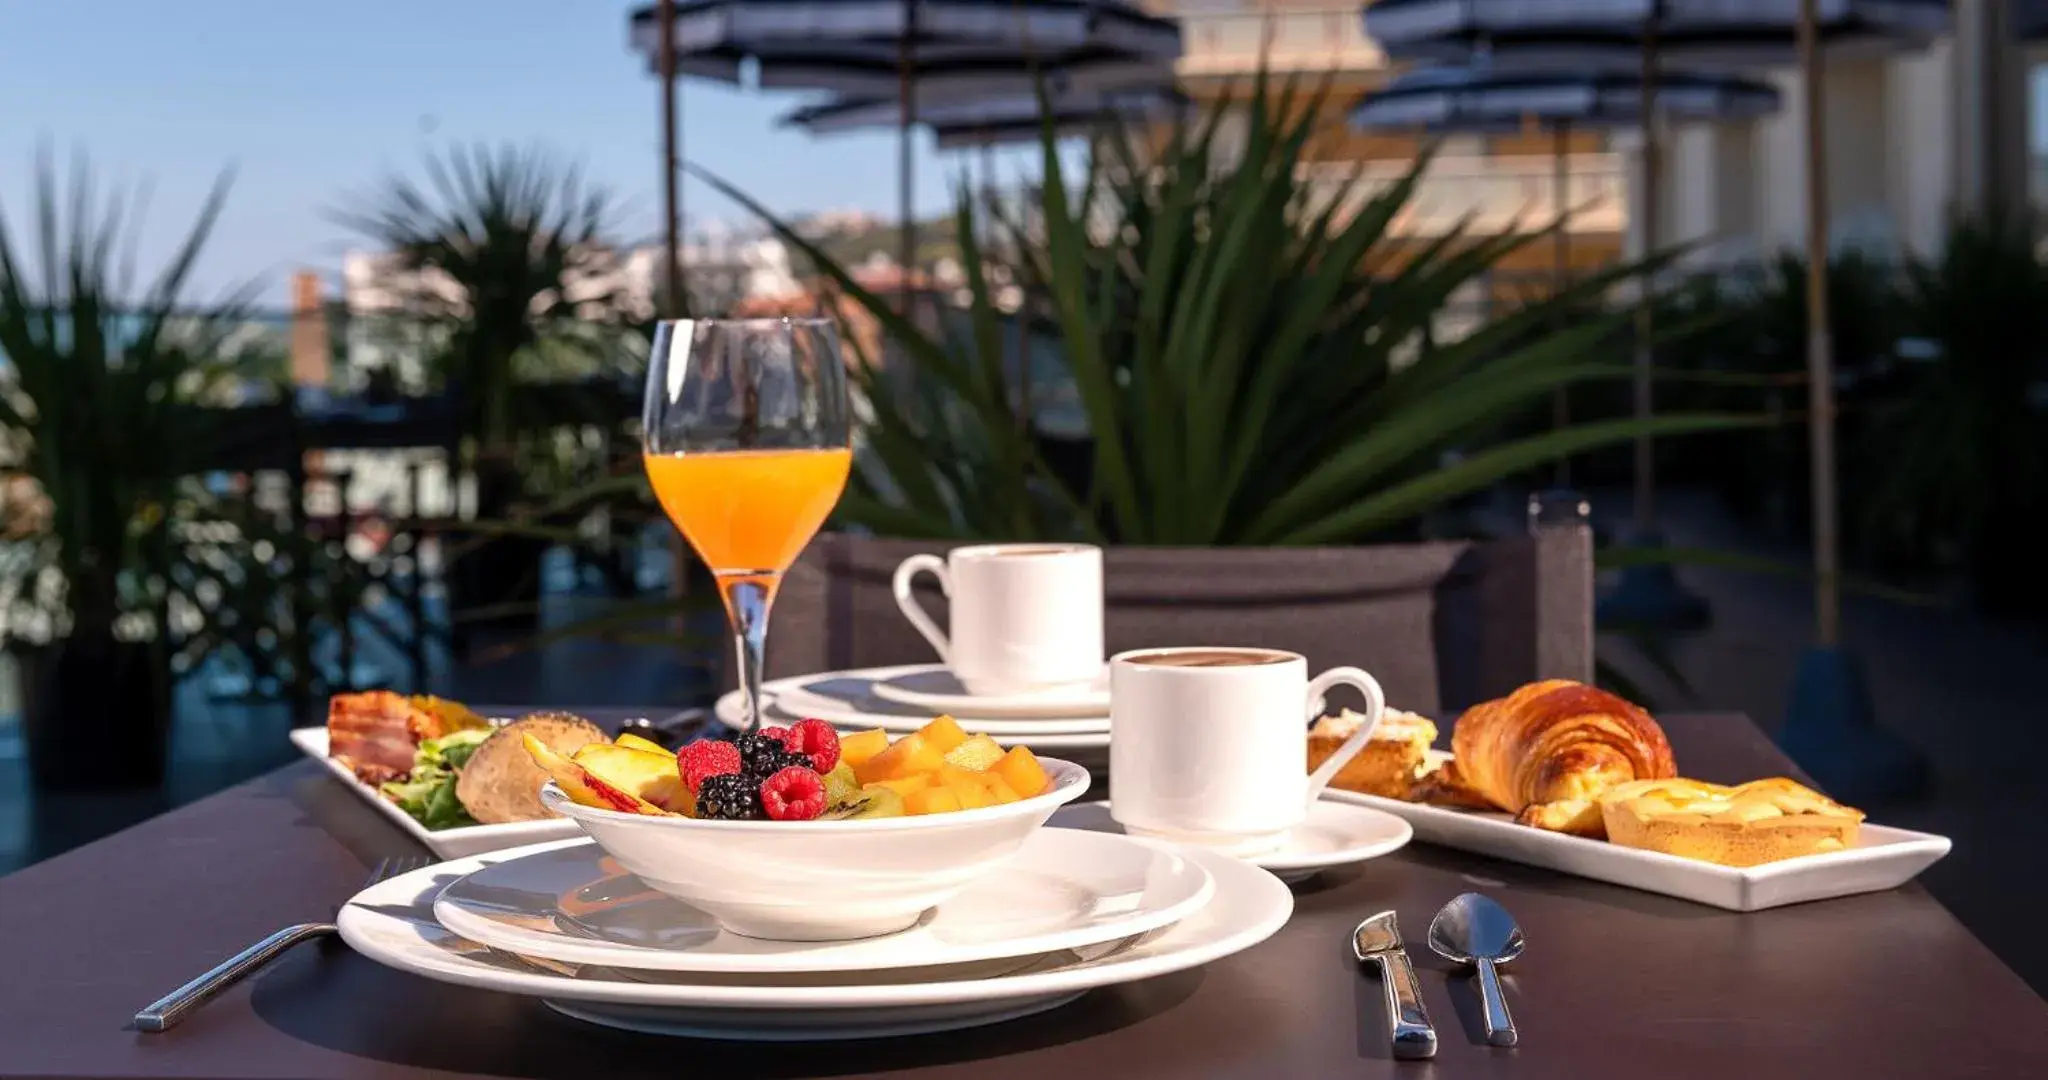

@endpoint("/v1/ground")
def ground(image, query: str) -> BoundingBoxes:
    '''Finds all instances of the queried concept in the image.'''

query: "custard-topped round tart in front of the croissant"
[1599,777,1864,867]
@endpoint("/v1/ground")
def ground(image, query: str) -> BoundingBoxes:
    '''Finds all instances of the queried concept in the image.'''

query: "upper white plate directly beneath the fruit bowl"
[434,832,1212,973]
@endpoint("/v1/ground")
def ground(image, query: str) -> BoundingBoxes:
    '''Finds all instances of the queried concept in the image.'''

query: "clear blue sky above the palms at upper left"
[0,0,1036,303]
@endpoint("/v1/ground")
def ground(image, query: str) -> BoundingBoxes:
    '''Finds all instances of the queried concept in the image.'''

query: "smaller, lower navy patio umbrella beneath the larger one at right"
[1352,61,1780,486]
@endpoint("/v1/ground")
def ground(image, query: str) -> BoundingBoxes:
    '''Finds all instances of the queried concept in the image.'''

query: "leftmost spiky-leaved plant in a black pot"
[0,160,266,789]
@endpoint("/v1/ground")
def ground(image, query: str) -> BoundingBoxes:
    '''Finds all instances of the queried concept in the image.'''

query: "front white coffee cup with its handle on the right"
[1110,648,1386,855]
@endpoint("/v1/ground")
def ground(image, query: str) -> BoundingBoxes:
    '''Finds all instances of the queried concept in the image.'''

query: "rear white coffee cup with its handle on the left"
[895,543,1102,697]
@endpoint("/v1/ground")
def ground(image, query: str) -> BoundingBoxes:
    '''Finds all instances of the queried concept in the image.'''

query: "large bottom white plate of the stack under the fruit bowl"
[336,827,1294,1039]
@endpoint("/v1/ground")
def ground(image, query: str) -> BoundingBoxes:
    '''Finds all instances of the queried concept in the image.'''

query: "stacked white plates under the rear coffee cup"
[713,664,1110,758]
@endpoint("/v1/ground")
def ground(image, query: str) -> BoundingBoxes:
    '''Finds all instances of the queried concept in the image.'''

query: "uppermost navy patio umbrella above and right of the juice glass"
[633,0,1180,301]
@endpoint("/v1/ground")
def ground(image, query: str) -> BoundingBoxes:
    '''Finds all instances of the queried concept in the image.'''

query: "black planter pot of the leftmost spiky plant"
[14,635,170,791]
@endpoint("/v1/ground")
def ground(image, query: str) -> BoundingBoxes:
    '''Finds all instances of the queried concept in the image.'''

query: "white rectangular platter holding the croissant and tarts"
[1323,789,1950,912]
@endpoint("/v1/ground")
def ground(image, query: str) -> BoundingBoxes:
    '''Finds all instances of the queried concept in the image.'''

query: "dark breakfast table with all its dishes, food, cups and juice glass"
[0,320,2048,1080]
